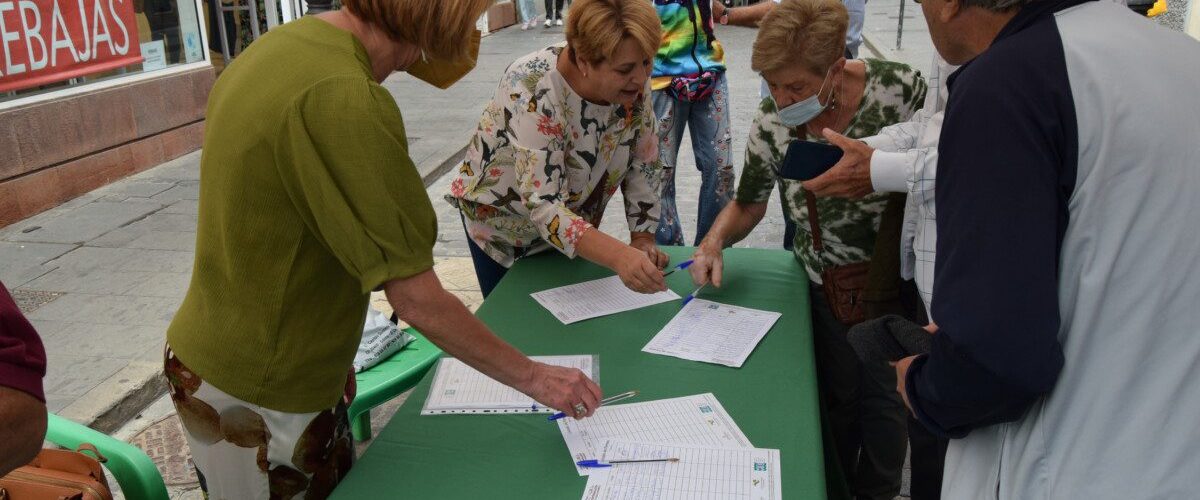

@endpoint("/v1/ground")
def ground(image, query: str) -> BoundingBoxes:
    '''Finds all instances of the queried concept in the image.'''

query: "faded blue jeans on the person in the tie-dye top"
[653,74,734,245]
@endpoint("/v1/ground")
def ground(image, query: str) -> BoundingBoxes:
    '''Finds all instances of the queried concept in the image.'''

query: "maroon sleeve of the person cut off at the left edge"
[0,283,46,402]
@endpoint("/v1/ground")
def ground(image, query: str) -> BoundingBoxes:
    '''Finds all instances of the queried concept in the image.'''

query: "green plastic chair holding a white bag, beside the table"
[348,329,442,441]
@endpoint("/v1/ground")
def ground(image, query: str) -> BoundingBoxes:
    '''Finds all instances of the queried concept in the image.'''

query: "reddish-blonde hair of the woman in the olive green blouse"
[342,0,492,60]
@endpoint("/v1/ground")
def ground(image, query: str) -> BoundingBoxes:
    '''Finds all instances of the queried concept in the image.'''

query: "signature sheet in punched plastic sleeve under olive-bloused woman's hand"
[421,355,599,415]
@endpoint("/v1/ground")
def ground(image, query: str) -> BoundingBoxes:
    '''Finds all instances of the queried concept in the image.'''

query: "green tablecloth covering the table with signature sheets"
[334,248,826,500]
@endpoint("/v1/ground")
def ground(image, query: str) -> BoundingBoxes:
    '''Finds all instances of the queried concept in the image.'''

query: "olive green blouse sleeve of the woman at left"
[275,77,437,293]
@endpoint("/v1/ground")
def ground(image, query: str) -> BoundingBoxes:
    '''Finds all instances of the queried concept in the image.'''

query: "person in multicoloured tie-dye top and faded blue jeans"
[650,0,733,245]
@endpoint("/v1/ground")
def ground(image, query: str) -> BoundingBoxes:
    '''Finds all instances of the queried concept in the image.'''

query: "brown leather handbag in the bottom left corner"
[0,444,113,500]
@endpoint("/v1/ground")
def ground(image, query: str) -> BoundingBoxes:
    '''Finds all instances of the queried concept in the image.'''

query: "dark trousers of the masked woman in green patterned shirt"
[810,285,907,500]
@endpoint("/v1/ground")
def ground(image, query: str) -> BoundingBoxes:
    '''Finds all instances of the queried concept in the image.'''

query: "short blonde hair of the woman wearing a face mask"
[750,0,850,74]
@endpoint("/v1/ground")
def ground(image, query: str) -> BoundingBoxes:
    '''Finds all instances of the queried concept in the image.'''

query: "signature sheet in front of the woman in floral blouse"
[530,276,679,325]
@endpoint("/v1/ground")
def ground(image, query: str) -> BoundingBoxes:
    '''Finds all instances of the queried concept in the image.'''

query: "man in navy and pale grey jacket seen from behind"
[896,0,1200,499]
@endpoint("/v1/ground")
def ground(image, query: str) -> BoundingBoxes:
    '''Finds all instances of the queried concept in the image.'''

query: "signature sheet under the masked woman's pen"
[642,299,780,368]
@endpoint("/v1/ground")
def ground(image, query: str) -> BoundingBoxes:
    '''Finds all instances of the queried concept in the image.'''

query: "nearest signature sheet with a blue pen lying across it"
[583,440,784,500]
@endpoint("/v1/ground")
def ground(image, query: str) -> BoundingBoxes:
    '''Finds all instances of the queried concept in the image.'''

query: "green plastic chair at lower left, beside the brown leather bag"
[46,414,169,500]
